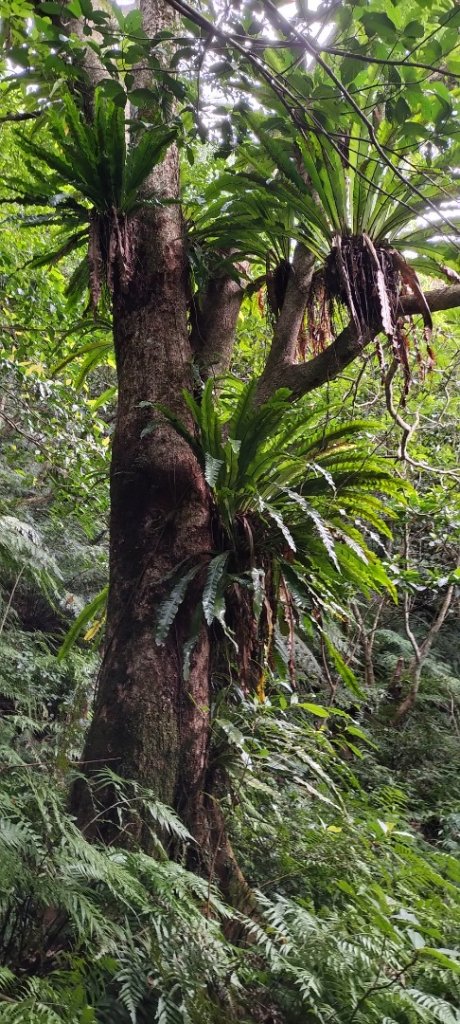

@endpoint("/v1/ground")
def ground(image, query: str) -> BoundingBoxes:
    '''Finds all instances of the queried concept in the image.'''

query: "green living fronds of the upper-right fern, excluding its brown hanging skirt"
[197,113,460,273]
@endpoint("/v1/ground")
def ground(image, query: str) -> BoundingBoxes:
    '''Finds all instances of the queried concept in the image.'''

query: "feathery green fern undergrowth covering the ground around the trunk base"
[0,655,460,1024]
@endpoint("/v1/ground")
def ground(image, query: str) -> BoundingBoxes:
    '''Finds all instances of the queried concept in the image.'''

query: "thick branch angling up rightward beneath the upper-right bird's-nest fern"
[258,285,460,401]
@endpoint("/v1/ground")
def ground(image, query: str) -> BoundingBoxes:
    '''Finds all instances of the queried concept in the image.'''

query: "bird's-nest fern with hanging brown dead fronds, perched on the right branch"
[196,113,460,383]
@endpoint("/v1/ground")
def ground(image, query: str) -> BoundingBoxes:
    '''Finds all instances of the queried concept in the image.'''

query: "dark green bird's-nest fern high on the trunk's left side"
[2,88,177,308]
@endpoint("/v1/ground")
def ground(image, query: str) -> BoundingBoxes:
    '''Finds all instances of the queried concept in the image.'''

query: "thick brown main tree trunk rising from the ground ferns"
[74,147,212,841]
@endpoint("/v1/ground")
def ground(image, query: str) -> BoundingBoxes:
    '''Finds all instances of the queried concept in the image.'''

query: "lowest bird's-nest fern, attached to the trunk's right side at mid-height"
[157,381,404,683]
